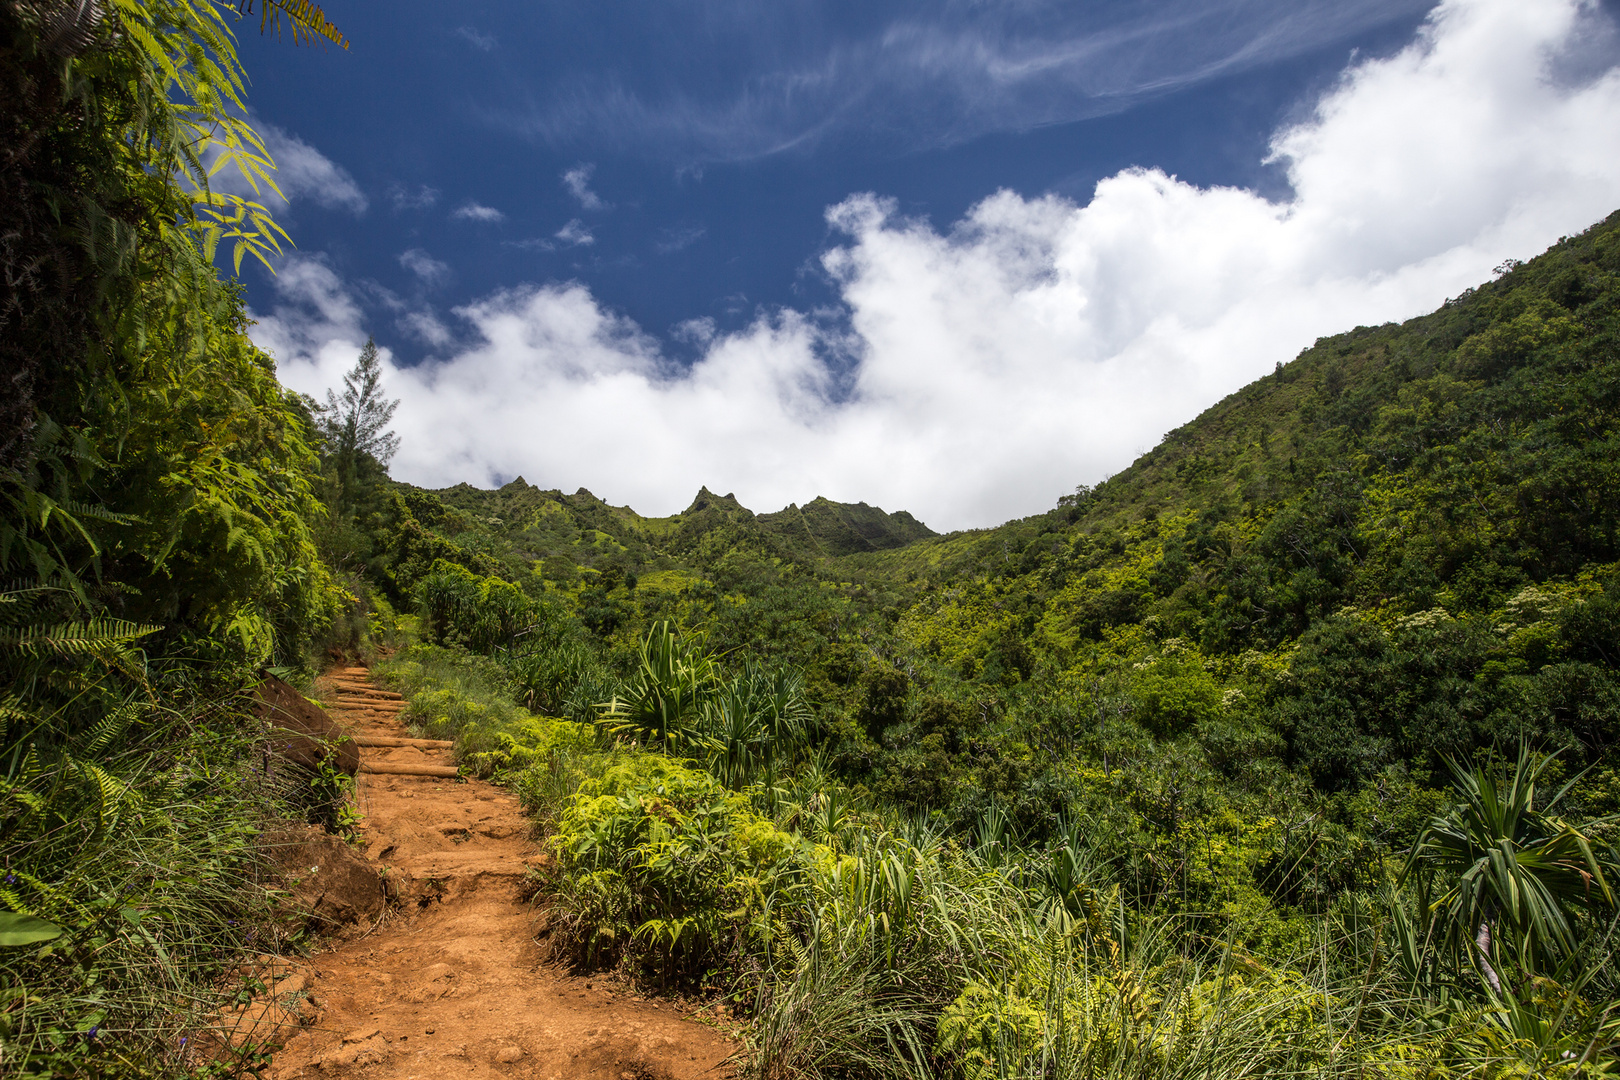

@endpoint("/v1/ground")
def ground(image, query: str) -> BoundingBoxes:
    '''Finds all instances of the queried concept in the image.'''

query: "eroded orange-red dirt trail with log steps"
[271,669,735,1080]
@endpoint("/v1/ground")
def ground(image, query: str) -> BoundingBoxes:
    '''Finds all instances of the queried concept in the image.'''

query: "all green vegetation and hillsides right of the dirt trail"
[351,217,1620,1077]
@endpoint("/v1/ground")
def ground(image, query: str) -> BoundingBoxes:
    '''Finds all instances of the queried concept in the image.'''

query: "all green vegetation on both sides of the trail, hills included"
[0,0,1620,1077]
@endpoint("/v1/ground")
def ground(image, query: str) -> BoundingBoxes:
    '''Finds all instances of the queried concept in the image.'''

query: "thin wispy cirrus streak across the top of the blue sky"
[505,0,1429,162]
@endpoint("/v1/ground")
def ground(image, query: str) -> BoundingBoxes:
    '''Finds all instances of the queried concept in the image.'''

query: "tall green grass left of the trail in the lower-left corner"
[0,685,288,1077]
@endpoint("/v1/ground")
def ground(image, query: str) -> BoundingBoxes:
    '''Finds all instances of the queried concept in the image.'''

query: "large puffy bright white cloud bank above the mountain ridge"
[256,0,1620,528]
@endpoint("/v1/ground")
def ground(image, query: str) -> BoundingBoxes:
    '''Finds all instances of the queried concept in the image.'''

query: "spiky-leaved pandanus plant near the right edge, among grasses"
[1401,748,1620,997]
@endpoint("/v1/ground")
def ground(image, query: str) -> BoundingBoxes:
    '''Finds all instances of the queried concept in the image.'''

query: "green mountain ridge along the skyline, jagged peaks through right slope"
[370,215,1620,806]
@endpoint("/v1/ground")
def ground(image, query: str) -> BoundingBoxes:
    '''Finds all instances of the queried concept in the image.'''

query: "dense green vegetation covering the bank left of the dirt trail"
[0,0,348,1077]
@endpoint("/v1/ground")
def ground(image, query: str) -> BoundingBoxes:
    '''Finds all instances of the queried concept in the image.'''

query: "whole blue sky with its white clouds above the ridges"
[241,0,1620,528]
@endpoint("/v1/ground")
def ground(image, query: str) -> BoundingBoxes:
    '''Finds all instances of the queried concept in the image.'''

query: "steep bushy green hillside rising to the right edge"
[833,208,1620,789]
